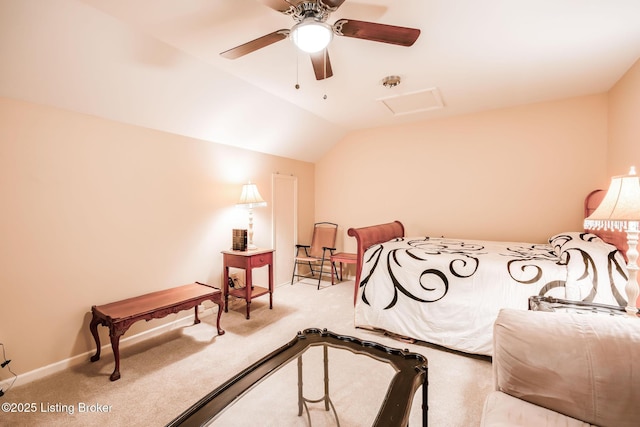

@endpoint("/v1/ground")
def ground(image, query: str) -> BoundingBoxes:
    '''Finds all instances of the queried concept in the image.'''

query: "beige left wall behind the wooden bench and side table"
[0,98,314,380]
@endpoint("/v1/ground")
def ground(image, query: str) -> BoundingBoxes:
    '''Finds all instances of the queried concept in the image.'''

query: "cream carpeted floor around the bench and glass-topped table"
[0,281,492,427]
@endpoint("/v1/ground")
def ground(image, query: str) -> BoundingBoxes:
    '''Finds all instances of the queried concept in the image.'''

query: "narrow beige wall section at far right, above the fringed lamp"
[602,60,640,176]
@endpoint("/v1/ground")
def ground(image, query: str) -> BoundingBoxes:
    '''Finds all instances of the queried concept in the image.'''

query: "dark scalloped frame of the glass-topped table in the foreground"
[167,328,428,427]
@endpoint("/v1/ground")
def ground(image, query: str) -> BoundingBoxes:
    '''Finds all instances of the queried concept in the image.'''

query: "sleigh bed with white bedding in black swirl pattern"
[348,190,628,356]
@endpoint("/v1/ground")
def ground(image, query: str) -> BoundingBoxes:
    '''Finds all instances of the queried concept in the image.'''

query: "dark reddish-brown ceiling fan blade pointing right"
[333,19,420,46]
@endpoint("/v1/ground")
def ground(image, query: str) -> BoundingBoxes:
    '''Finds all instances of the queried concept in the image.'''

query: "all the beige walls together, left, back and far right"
[0,57,640,380]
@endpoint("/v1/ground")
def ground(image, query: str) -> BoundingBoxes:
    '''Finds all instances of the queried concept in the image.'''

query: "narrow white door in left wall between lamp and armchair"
[271,174,298,286]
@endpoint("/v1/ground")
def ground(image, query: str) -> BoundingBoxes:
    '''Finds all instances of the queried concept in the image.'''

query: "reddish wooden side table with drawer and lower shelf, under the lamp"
[222,249,273,319]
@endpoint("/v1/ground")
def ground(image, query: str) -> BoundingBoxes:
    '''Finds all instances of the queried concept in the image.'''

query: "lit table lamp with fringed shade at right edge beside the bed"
[584,166,640,315]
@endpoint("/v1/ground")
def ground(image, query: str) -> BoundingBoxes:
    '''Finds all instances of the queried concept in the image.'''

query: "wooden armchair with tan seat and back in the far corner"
[291,222,338,289]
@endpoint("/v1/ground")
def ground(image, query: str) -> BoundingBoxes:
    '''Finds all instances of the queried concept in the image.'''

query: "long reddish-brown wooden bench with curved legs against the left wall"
[89,282,224,381]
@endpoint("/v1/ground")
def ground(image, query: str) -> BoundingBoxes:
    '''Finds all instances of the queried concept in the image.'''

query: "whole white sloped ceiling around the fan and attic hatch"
[0,0,640,162]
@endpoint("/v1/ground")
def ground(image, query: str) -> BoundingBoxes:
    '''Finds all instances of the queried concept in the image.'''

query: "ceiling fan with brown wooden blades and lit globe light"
[220,0,420,80]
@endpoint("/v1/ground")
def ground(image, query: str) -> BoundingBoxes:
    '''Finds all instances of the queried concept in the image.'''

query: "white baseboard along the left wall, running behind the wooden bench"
[0,307,202,392]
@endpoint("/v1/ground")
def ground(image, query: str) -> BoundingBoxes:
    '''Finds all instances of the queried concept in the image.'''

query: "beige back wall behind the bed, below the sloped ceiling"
[316,94,608,251]
